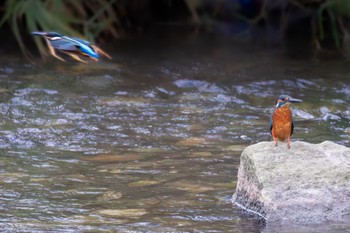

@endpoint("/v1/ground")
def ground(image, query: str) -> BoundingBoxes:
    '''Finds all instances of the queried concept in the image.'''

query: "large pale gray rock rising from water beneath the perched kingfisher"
[233,141,350,223]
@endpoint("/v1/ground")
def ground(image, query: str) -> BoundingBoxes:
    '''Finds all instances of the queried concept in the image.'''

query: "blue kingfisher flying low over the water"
[32,32,111,63]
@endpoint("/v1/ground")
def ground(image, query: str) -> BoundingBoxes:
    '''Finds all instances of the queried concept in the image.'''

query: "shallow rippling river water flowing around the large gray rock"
[0,39,350,233]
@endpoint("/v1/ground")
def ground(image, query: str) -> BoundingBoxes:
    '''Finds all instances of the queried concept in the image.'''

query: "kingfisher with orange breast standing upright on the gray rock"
[270,95,303,149]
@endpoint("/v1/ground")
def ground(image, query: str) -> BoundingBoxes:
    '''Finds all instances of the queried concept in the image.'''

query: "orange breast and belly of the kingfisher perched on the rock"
[272,106,292,141]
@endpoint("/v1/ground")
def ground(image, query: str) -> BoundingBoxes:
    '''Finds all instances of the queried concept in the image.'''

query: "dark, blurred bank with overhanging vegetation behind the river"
[0,0,350,57]
